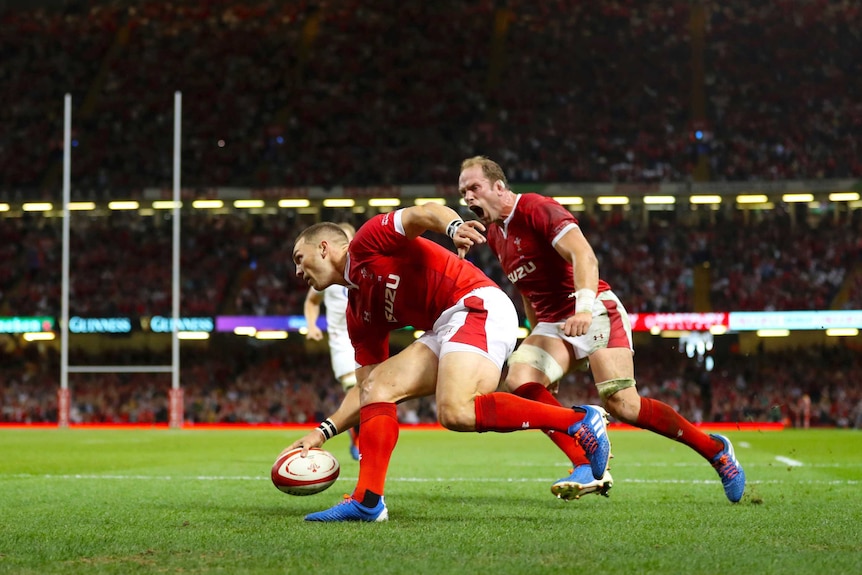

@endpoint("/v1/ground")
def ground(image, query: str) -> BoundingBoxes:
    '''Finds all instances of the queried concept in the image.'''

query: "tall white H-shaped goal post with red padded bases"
[57,92,184,428]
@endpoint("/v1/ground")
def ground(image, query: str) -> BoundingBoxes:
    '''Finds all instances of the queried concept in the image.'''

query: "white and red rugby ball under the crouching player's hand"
[272,447,341,495]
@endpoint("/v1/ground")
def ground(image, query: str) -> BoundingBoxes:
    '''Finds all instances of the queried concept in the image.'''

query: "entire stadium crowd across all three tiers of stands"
[0,0,862,428]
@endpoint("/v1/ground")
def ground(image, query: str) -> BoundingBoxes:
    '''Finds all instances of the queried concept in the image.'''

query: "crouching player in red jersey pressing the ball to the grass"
[288,204,610,522]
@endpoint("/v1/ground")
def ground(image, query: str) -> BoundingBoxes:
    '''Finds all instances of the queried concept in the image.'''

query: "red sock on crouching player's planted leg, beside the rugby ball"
[353,403,398,501]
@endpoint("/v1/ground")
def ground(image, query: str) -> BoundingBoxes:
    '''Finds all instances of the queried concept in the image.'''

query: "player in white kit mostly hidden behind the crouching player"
[303,223,359,460]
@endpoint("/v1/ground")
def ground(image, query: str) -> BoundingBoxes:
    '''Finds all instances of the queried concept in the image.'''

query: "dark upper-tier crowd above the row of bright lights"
[0,0,862,197]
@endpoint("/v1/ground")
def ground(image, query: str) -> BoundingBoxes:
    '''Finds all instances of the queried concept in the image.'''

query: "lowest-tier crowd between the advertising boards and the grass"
[0,336,862,429]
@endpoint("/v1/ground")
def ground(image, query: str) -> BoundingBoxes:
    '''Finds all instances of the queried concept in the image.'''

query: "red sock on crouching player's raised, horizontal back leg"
[476,391,584,434]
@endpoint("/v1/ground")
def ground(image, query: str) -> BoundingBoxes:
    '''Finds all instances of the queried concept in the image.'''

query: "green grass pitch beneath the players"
[0,429,862,575]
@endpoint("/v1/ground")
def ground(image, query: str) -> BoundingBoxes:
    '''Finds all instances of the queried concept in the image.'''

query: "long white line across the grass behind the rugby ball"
[0,473,862,485]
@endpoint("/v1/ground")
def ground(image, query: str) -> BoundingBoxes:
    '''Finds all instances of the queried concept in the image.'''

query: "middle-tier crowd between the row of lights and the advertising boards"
[0,208,862,317]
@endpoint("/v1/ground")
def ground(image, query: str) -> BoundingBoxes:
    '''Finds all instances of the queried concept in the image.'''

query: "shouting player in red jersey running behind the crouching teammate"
[458,156,745,503]
